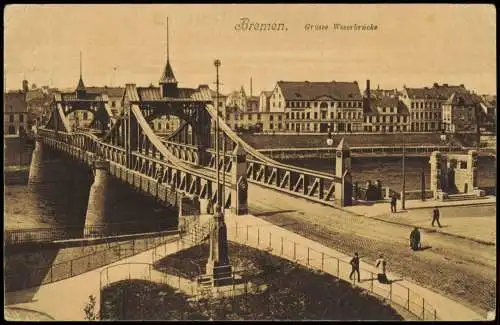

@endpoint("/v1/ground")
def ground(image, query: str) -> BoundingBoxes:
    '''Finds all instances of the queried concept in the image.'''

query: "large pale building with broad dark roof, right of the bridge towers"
[270,81,363,132]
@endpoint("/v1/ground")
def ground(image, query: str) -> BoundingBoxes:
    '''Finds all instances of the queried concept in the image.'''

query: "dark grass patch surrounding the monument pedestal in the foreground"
[101,242,403,320]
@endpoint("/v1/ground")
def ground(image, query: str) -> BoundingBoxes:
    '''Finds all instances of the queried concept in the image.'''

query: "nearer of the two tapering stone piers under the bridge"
[84,160,109,237]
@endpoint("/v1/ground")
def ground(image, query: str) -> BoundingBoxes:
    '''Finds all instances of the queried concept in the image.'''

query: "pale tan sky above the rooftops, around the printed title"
[4,4,496,95]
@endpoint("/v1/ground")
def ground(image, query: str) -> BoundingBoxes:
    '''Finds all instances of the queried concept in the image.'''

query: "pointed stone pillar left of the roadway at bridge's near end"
[231,145,248,215]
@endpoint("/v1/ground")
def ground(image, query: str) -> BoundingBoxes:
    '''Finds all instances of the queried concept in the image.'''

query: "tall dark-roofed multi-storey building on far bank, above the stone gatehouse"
[400,83,467,132]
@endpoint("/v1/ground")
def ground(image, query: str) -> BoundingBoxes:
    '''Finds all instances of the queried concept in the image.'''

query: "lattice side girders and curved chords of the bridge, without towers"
[38,100,341,206]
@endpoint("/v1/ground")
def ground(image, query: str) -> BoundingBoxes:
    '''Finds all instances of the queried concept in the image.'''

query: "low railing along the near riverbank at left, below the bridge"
[4,221,176,246]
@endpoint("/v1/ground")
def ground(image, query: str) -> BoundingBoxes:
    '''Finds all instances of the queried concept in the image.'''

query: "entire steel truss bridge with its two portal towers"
[36,84,342,215]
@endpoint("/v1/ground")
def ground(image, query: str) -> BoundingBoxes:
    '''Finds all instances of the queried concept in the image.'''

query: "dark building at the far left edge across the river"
[3,91,29,135]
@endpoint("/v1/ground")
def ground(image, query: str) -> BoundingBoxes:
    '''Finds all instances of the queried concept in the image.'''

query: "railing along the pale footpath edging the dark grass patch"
[232,223,439,320]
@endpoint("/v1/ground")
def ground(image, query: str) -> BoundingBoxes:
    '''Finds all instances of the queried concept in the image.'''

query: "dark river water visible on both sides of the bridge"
[4,157,496,229]
